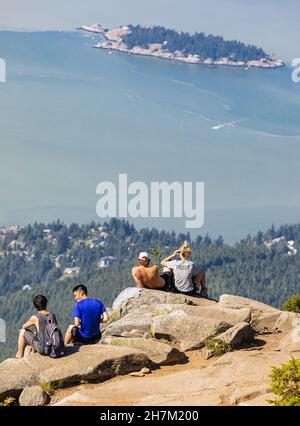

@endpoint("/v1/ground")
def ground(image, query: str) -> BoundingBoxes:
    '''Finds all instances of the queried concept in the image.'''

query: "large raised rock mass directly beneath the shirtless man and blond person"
[103,288,251,351]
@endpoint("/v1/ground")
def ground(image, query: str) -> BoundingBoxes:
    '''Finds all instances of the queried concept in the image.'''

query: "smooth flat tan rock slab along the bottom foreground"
[56,351,289,406]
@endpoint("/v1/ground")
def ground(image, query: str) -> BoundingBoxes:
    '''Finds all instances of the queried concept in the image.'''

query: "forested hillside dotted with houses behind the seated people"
[0,219,300,359]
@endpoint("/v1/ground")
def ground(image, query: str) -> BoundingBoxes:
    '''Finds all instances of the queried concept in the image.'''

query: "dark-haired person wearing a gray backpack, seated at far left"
[16,295,64,359]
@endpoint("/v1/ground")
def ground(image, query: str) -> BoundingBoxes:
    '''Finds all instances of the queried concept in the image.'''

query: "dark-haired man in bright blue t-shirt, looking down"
[65,284,108,345]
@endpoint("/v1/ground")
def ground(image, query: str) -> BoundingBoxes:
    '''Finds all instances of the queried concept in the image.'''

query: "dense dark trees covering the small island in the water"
[122,25,268,62]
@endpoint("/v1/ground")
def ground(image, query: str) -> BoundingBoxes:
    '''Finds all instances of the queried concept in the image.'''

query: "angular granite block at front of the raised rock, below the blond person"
[151,310,231,351]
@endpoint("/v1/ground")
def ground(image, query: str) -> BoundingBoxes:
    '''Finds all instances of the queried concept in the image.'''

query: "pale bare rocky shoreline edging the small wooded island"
[79,24,285,69]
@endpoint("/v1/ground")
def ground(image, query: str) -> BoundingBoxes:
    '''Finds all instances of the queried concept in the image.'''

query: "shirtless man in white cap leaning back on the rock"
[132,251,172,291]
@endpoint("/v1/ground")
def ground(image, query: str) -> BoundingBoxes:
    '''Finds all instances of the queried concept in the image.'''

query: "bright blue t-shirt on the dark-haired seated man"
[73,297,106,339]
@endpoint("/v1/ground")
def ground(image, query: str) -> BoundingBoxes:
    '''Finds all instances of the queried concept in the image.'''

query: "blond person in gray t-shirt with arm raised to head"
[161,241,208,297]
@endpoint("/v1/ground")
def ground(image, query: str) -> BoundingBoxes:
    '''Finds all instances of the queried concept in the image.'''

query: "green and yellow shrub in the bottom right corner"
[268,357,300,406]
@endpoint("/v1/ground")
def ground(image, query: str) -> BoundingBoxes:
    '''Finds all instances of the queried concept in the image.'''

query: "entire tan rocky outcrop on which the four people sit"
[0,287,300,405]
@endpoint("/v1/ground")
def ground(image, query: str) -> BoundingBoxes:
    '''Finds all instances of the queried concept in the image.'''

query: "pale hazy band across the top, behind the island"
[0,0,300,61]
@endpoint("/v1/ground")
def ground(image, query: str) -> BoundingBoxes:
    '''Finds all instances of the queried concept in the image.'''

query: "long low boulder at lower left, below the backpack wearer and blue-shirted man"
[0,344,153,400]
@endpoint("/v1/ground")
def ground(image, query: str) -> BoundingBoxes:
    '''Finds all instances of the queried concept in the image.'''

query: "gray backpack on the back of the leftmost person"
[42,313,65,358]
